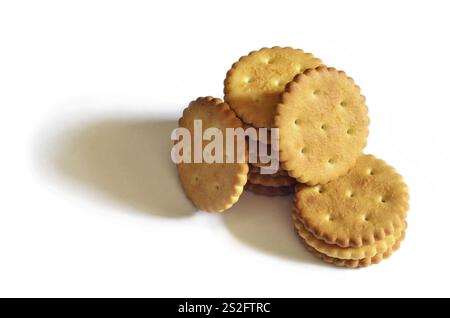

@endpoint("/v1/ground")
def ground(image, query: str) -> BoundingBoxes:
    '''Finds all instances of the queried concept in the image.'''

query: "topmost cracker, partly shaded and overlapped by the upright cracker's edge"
[224,47,322,128]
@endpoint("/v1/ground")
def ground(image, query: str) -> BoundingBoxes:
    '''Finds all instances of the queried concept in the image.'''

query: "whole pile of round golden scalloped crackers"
[176,47,409,268]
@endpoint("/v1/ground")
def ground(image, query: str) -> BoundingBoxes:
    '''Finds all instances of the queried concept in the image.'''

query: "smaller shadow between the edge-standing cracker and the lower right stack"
[223,191,327,266]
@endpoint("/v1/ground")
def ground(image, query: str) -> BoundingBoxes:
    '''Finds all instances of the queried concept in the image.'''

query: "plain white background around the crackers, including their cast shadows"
[0,0,450,297]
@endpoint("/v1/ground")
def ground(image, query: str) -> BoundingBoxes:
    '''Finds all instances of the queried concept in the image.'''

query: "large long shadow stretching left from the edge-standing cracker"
[50,119,196,217]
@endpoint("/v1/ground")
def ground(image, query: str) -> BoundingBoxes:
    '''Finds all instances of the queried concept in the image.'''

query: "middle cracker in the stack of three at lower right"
[292,210,406,260]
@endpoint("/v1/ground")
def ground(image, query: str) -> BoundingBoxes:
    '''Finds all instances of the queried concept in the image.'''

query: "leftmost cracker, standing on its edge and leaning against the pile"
[177,97,248,212]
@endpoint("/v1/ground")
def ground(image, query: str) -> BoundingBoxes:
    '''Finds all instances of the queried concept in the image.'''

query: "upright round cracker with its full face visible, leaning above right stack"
[274,66,369,185]
